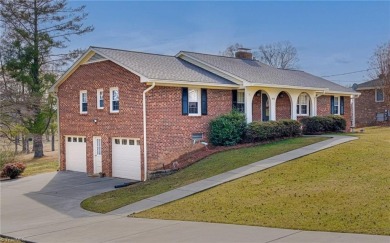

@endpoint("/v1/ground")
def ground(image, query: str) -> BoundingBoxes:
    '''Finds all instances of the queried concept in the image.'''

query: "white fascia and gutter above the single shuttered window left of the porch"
[146,79,241,89]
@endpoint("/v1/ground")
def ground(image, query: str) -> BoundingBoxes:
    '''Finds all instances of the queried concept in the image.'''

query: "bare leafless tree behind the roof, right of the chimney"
[256,41,299,69]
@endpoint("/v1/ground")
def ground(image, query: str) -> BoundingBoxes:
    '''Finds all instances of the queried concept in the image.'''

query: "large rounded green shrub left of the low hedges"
[209,111,246,146]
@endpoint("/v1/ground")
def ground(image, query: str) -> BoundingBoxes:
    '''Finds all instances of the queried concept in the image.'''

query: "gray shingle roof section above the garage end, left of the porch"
[91,47,234,84]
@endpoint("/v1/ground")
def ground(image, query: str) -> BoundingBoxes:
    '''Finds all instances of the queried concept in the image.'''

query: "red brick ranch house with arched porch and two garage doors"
[51,47,358,180]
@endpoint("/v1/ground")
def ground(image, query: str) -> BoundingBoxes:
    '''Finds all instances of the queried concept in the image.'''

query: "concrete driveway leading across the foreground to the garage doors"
[0,172,390,243]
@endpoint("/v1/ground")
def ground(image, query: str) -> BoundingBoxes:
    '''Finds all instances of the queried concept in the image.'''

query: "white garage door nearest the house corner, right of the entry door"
[112,138,141,181]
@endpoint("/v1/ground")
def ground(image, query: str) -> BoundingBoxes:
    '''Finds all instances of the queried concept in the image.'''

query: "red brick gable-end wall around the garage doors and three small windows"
[58,61,146,176]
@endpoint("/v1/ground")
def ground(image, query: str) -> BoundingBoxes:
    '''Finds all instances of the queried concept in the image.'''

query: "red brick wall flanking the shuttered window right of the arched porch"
[317,95,351,131]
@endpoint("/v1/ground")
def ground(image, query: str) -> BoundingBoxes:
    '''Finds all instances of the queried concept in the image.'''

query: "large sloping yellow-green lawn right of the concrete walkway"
[134,127,390,235]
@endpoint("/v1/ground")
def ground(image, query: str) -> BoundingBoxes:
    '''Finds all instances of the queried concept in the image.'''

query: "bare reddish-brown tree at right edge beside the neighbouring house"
[369,41,390,98]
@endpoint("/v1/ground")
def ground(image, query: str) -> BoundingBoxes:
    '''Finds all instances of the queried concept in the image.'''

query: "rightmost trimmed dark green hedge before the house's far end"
[301,115,347,134]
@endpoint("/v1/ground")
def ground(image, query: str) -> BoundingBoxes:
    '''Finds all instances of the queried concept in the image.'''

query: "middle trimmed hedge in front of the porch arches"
[246,120,302,142]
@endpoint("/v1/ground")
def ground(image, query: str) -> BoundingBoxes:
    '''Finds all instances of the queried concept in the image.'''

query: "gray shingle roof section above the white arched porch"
[181,51,354,92]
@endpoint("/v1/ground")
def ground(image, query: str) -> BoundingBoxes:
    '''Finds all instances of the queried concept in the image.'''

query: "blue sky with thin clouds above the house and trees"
[70,1,390,85]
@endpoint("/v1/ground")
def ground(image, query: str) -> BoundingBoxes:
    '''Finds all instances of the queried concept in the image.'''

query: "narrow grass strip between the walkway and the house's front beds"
[81,137,324,213]
